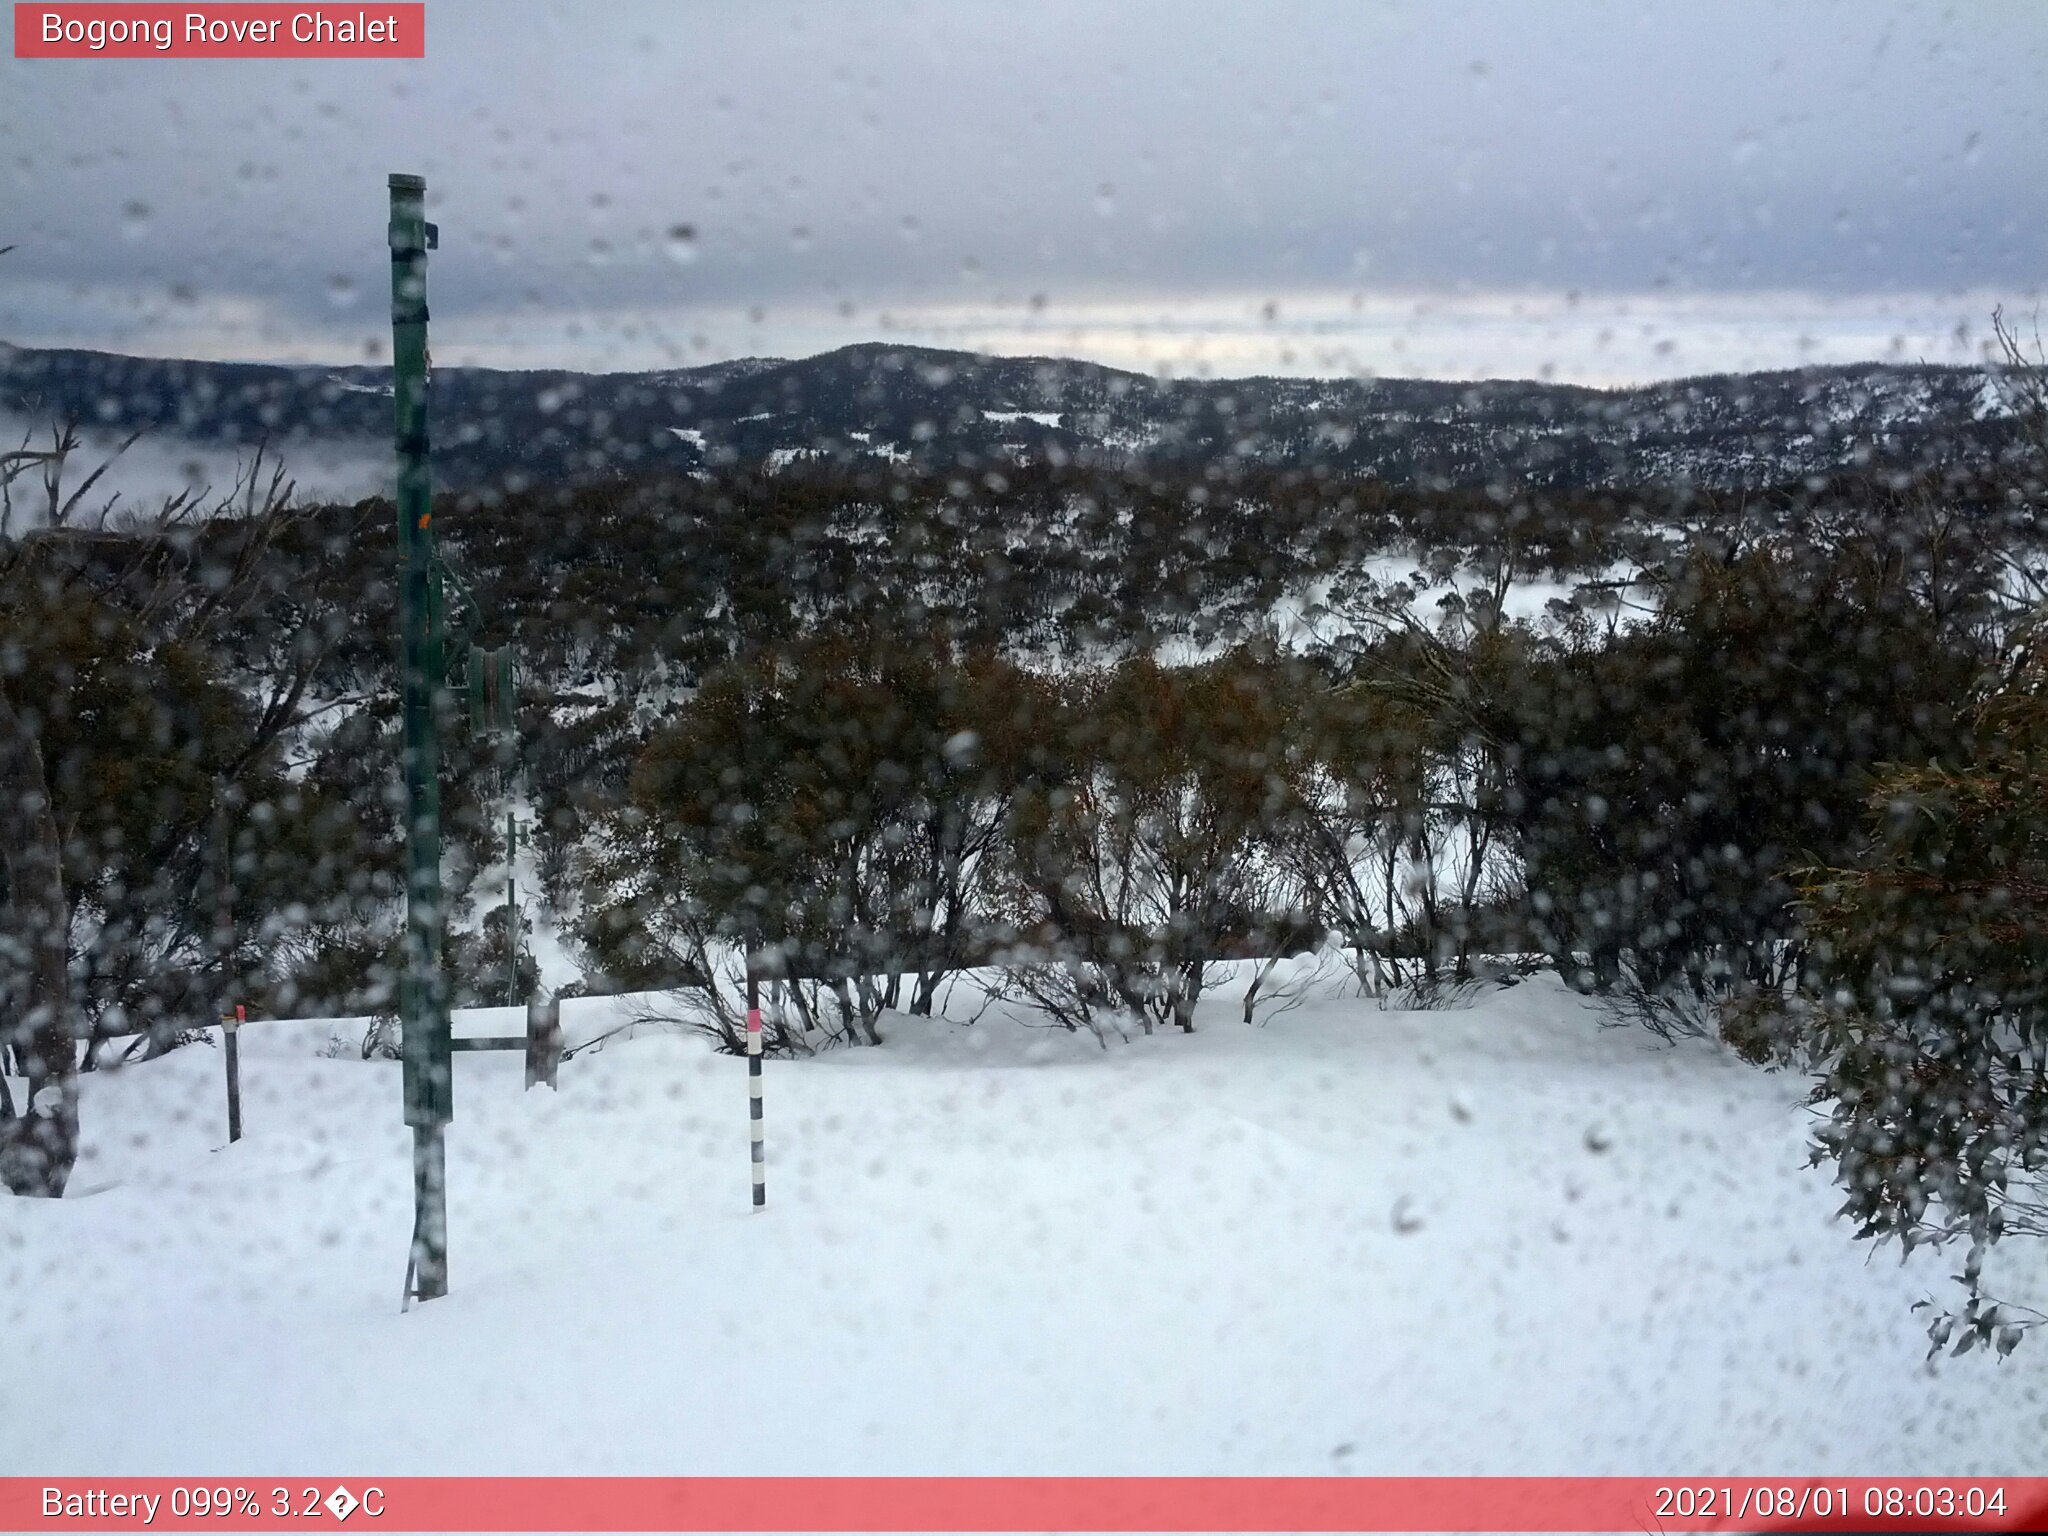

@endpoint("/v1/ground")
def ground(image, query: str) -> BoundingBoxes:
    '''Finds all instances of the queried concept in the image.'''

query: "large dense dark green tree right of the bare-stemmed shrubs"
[1495,545,1978,1011]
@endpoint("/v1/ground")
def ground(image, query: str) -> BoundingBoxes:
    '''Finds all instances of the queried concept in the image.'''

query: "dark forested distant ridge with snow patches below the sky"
[0,344,2015,499]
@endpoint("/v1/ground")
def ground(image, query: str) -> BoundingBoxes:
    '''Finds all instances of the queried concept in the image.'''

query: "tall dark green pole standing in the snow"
[389,176,455,1300]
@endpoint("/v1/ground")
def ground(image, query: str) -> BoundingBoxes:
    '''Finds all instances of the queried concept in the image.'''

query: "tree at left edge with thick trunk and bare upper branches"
[0,450,354,1196]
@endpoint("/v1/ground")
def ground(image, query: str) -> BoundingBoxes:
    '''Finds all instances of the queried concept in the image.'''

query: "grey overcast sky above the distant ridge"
[0,0,2048,383]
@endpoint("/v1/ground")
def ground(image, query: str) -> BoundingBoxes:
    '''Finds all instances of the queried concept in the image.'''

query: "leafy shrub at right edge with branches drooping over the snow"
[1802,623,2048,1354]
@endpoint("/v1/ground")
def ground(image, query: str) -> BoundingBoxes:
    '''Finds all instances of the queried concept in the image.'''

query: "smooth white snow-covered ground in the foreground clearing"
[0,981,2048,1475]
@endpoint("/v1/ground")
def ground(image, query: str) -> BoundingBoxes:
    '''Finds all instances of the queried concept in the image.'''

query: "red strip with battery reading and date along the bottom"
[0,1477,2048,1532]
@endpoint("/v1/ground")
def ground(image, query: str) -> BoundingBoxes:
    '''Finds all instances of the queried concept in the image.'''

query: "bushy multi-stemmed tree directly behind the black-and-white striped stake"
[588,629,1047,1042]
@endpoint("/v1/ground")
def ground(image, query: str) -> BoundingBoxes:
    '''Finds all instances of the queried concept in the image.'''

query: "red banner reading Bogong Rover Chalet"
[14,0,426,59]
